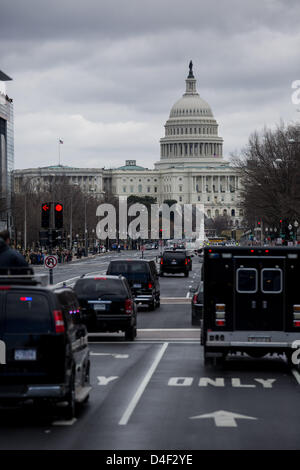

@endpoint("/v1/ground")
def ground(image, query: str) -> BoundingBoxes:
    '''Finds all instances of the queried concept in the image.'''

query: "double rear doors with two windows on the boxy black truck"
[234,256,285,331]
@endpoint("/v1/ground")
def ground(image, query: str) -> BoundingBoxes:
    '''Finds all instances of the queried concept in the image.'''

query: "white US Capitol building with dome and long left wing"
[14,62,243,227]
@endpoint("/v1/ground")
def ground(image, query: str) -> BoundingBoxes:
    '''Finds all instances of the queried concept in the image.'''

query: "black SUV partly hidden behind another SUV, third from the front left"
[107,259,160,310]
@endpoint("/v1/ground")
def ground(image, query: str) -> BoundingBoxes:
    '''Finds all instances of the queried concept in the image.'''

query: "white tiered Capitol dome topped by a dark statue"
[156,61,223,168]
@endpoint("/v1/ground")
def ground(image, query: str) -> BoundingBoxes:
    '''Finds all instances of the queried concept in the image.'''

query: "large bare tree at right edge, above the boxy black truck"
[233,124,300,228]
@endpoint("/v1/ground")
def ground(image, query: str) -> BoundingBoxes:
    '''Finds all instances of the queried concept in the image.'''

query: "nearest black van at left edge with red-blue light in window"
[0,274,91,419]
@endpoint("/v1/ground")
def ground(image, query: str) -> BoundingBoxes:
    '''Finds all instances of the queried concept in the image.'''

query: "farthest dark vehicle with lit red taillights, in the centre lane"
[160,249,192,277]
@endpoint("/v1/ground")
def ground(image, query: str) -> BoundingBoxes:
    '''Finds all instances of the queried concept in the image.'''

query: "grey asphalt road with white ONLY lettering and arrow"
[0,252,300,450]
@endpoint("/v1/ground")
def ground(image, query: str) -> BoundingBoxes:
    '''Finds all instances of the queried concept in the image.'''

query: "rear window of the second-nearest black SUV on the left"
[74,278,126,296]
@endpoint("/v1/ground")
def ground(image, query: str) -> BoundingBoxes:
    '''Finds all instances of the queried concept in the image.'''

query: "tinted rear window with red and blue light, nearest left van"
[5,292,52,333]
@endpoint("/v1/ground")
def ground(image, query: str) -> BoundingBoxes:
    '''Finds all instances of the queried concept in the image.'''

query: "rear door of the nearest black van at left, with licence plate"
[0,289,65,385]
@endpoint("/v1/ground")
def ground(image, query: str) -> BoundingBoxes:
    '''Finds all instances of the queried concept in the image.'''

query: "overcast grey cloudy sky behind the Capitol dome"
[0,0,300,168]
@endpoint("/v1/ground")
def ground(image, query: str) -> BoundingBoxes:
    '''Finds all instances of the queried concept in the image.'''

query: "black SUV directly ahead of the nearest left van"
[74,275,137,341]
